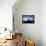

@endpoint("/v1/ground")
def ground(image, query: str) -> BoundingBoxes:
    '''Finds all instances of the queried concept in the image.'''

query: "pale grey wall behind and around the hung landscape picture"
[13,0,41,46]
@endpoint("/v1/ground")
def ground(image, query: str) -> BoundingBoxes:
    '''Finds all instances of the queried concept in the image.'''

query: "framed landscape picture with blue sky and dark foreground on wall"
[22,15,35,23]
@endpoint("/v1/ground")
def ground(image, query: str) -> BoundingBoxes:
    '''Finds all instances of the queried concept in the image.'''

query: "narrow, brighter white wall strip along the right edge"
[41,0,46,46]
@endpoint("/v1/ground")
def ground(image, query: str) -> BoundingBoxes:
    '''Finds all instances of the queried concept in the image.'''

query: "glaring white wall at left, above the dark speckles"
[0,0,16,29]
